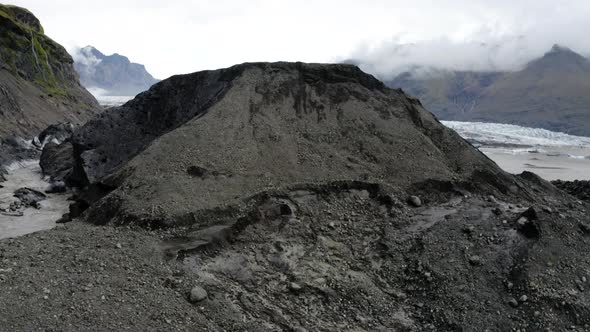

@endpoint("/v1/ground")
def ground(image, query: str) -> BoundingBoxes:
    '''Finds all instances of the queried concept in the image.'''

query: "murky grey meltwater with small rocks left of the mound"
[0,160,69,239]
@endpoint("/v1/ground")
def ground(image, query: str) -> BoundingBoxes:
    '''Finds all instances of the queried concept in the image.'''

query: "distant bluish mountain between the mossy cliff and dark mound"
[74,46,159,96]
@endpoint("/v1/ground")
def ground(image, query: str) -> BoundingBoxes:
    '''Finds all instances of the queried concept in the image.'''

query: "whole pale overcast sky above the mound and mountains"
[11,0,590,78]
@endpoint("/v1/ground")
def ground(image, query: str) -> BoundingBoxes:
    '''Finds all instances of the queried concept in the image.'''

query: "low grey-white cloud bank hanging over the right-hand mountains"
[342,0,590,79]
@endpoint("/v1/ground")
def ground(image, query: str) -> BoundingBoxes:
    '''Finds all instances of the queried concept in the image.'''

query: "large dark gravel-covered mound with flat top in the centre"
[61,63,524,221]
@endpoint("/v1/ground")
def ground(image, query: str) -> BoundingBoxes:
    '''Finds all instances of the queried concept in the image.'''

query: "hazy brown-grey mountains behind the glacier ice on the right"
[386,45,590,136]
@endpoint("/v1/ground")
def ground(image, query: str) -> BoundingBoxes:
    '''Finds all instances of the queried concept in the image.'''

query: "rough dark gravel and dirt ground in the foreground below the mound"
[0,184,590,331]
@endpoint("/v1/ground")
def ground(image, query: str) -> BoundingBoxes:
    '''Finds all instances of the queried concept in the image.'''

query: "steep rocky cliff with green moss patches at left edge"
[0,4,100,162]
